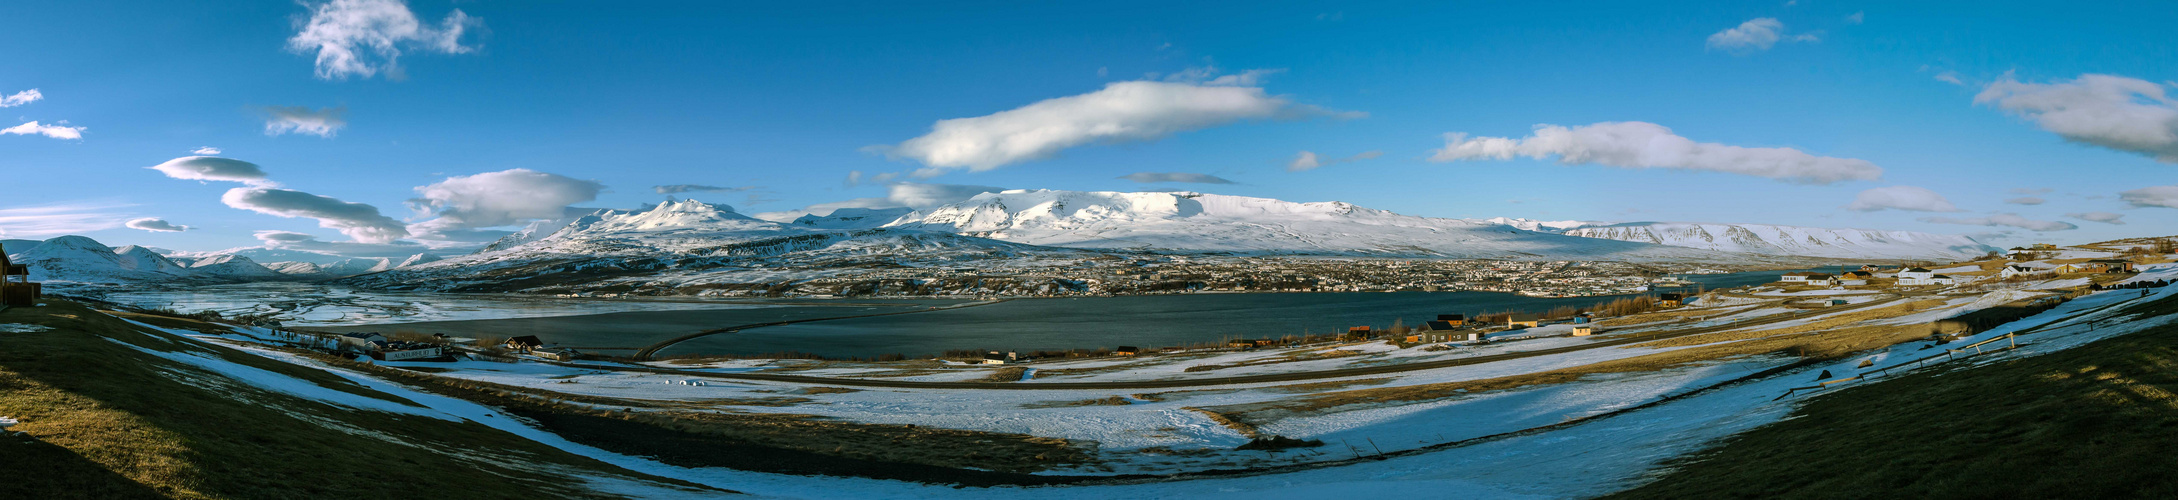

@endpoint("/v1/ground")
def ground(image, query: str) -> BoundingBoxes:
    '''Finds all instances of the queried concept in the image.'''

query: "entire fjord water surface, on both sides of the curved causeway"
[123,267,1838,357]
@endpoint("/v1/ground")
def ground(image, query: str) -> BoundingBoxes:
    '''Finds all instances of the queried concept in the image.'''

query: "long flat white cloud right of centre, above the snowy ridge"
[1429,122,1884,185]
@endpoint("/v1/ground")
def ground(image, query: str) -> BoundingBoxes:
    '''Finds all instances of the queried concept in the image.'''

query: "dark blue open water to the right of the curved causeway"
[653,267,1840,357]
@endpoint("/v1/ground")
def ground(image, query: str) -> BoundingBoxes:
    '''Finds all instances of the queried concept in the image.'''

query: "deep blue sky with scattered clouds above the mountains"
[0,0,2178,252]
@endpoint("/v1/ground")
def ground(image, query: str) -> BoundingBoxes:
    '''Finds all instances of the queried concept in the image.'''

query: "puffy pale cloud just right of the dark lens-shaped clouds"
[409,167,605,235]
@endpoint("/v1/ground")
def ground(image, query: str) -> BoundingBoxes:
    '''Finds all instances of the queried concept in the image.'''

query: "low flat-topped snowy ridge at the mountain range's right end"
[1566,222,1997,259]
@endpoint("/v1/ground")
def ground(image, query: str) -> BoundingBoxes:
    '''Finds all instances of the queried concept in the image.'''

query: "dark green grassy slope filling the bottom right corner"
[1614,298,2178,498]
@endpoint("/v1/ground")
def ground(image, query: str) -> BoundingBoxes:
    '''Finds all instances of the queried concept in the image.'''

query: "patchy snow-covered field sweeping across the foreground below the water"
[106,259,2178,498]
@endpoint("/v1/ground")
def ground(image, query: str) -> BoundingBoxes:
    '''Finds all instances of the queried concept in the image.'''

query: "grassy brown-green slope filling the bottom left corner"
[0,300,725,498]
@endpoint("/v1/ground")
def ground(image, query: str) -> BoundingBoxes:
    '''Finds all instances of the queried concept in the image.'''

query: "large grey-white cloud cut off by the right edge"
[1973,74,2178,163]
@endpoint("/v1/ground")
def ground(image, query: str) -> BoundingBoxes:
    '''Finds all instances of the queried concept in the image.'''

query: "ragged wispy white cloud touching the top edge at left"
[287,0,484,80]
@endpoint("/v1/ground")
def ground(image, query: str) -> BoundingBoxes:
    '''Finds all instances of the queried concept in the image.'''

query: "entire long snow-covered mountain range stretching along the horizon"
[9,189,1993,291]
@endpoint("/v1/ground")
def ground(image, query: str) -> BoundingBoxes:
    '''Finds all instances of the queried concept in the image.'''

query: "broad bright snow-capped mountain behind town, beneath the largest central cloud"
[886,189,1732,261]
